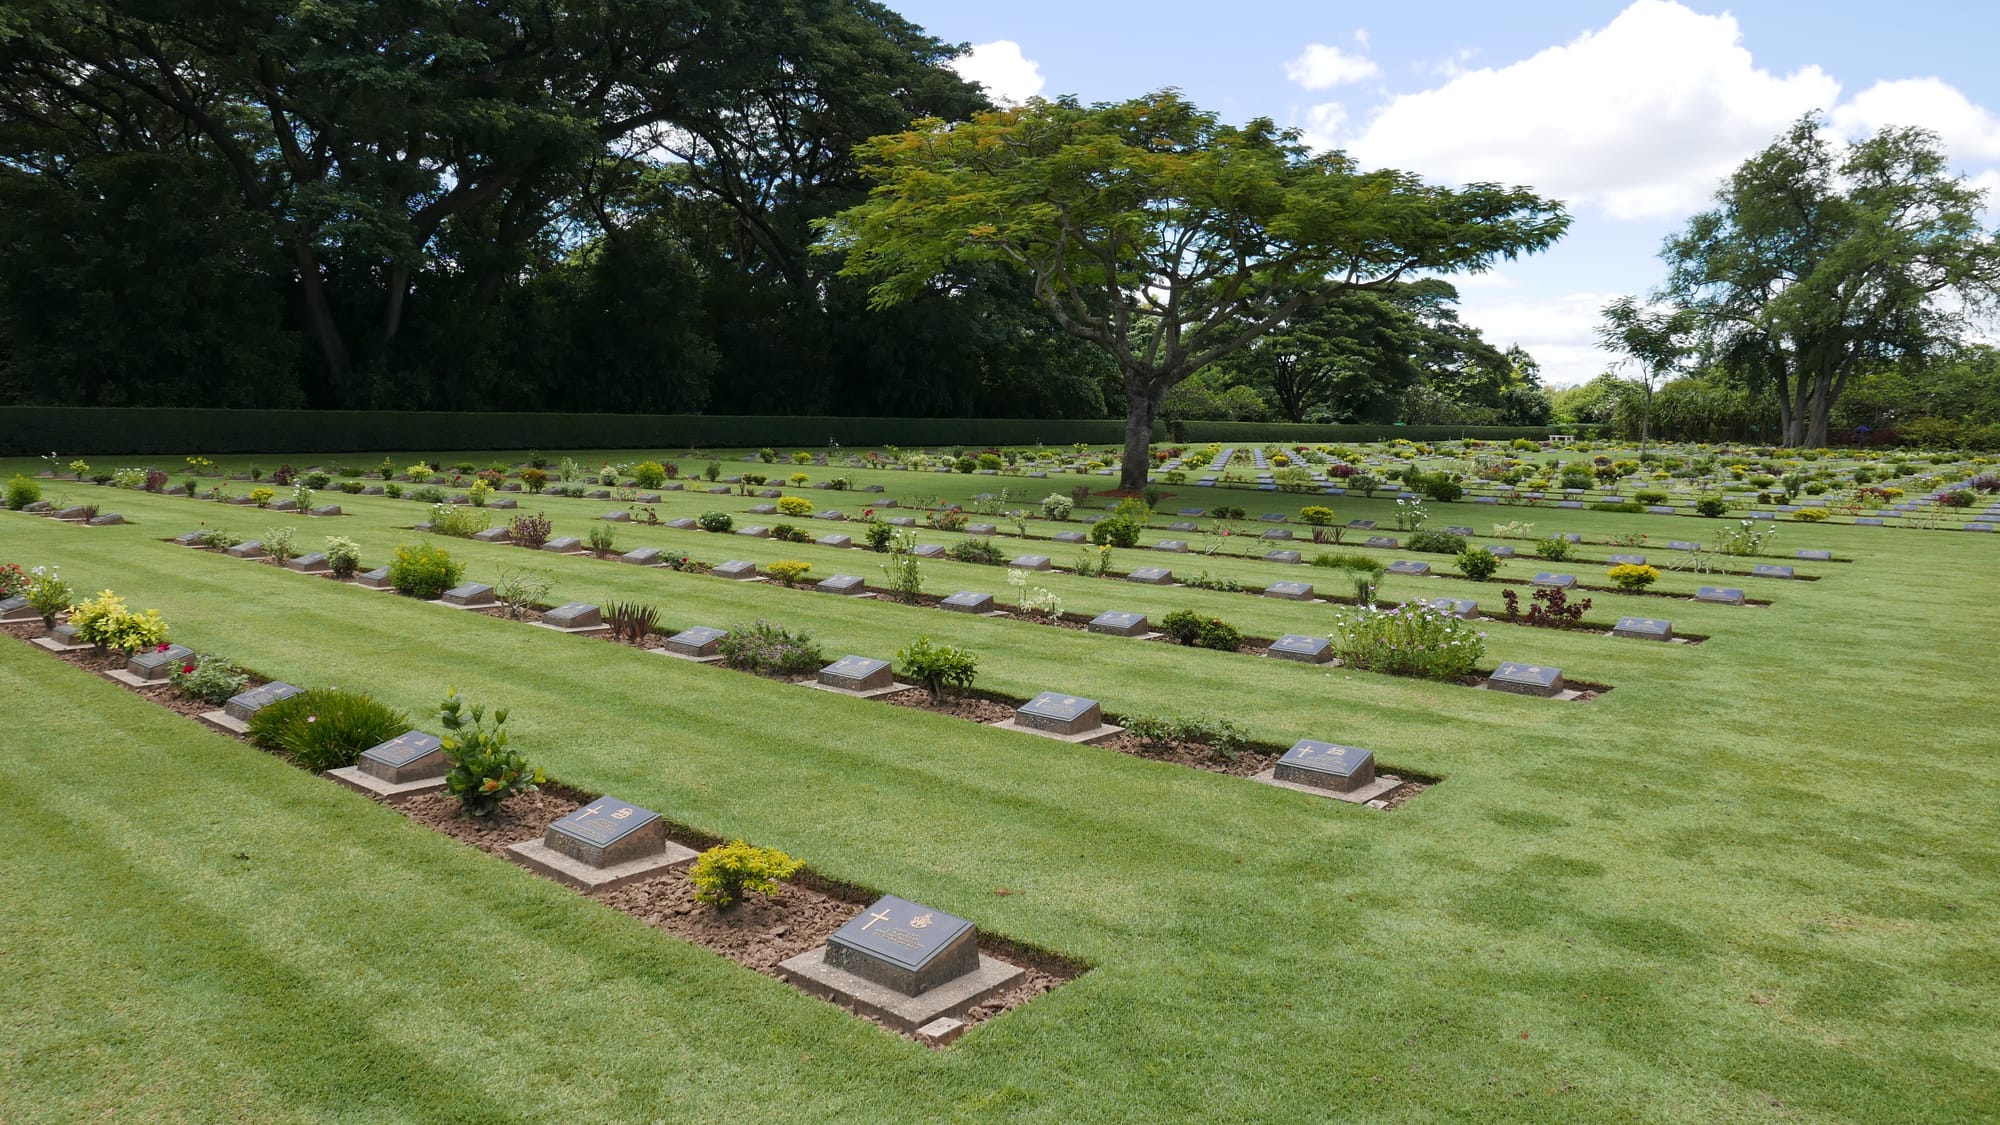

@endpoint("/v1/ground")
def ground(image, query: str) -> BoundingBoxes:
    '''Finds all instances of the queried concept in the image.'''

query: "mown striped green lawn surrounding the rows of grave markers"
[0,452,2000,1123]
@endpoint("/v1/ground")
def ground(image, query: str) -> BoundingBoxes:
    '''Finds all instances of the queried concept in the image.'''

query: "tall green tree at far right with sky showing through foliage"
[1662,114,2000,446]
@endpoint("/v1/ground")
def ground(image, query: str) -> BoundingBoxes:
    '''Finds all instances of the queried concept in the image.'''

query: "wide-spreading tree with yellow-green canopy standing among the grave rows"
[822,90,1568,490]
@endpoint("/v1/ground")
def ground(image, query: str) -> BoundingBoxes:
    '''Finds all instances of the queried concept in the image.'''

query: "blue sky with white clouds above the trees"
[888,0,2000,384]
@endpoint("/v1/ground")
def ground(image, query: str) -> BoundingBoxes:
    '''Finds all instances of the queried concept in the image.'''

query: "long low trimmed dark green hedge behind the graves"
[0,406,1548,456]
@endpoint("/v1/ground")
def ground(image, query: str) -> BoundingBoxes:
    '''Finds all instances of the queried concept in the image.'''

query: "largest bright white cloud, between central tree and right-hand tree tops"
[1348,0,1840,218]
